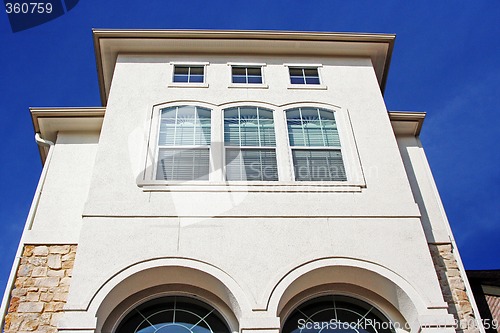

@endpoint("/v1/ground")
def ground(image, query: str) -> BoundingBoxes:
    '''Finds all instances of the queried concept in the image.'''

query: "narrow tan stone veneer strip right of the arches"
[429,244,479,333]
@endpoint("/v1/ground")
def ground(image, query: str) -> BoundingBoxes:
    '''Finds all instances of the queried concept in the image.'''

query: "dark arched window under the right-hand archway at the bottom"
[282,295,395,333]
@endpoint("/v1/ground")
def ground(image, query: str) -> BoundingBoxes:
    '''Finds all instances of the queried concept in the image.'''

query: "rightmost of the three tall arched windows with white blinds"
[286,107,347,181]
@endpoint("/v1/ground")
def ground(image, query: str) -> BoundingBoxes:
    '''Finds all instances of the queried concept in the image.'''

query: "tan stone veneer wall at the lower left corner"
[4,245,76,333]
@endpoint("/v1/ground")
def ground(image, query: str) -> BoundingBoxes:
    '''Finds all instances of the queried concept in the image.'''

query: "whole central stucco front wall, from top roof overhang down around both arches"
[57,55,449,331]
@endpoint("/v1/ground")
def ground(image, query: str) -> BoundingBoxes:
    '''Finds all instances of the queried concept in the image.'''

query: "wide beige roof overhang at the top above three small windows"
[93,29,396,105]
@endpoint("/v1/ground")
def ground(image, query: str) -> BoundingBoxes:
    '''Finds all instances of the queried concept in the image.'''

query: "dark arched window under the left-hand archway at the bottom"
[116,296,230,333]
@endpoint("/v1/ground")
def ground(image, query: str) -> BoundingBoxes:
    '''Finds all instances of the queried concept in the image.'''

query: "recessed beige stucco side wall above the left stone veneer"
[23,132,99,244]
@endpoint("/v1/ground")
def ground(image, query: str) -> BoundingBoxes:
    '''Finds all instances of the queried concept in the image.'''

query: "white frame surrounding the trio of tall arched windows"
[137,101,366,192]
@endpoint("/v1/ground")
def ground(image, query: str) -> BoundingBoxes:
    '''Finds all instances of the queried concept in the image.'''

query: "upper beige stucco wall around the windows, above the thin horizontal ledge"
[84,56,418,216]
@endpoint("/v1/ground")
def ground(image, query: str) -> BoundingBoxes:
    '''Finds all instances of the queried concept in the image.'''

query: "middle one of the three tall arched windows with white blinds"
[224,106,278,181]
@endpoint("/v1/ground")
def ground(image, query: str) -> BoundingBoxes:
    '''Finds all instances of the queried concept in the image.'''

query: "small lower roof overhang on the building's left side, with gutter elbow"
[30,107,106,163]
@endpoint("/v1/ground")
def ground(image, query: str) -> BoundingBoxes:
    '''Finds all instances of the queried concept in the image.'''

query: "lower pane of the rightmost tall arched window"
[292,149,347,181]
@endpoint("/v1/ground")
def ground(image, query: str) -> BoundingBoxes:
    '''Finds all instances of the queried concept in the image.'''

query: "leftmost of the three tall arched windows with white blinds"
[156,105,211,180]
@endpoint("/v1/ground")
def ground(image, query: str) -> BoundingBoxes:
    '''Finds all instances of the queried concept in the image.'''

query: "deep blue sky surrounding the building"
[0,0,500,290]
